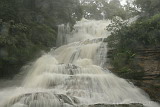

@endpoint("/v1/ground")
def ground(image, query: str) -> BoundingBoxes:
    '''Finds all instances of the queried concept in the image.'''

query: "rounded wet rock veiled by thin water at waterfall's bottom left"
[4,92,78,107]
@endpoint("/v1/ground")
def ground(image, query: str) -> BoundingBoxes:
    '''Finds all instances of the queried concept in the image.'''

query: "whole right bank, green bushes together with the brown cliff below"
[108,0,160,102]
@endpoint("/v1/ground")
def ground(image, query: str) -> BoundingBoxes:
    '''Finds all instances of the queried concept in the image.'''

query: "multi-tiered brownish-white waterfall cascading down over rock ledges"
[0,19,159,107]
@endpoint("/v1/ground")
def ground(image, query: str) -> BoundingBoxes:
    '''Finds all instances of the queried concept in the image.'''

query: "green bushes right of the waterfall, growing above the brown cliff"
[107,14,160,79]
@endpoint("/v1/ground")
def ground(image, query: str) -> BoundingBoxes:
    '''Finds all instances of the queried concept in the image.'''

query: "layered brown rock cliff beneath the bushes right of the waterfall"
[108,48,160,102]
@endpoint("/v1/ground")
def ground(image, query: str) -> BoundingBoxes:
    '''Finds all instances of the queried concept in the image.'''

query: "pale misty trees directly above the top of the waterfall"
[81,0,131,20]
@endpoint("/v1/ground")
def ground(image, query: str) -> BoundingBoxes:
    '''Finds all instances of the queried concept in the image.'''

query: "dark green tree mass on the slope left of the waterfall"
[0,0,82,77]
